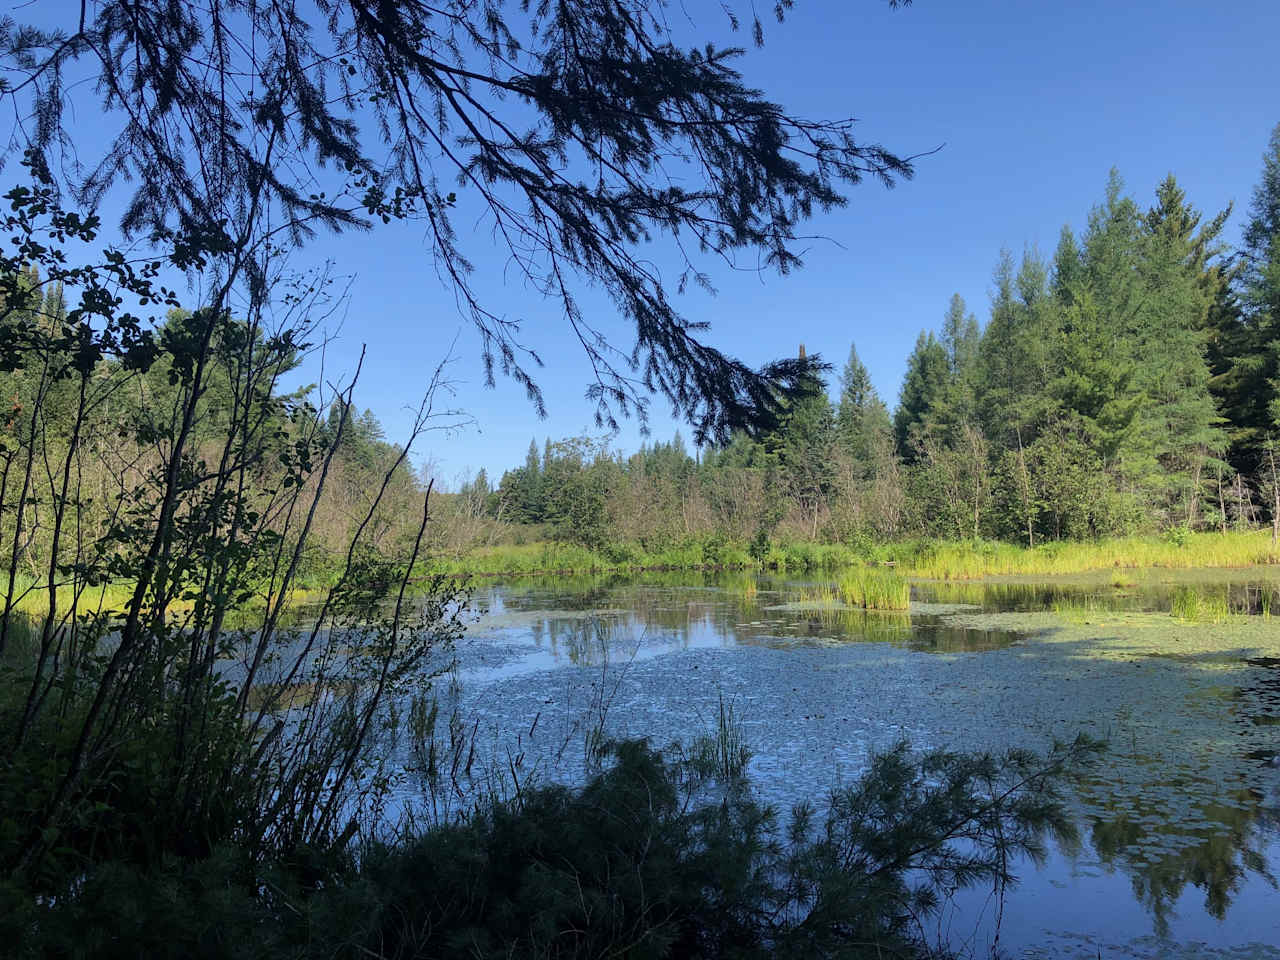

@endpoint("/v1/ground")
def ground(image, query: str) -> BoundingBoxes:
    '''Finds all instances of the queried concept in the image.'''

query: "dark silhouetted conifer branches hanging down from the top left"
[0,0,911,439]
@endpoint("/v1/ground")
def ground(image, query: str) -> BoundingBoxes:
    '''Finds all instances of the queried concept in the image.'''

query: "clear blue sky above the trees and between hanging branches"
[27,0,1280,485]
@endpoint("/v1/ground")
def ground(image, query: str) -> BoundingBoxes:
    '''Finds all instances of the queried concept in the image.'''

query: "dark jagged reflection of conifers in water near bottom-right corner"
[1091,783,1276,936]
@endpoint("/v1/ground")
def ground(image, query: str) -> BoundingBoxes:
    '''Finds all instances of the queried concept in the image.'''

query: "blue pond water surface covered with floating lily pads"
[412,570,1280,957]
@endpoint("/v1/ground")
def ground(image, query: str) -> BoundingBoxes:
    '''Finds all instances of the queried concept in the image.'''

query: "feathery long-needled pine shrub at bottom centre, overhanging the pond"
[312,741,1094,959]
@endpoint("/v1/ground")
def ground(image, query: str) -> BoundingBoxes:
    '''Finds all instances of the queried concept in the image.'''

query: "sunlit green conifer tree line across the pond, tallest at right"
[476,125,1280,547]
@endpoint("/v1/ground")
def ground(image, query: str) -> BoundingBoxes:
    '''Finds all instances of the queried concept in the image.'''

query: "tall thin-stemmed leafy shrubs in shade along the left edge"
[0,176,466,926]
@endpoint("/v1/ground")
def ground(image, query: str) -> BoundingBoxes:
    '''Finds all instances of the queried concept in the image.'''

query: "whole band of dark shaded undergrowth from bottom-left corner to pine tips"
[10,741,1093,960]
